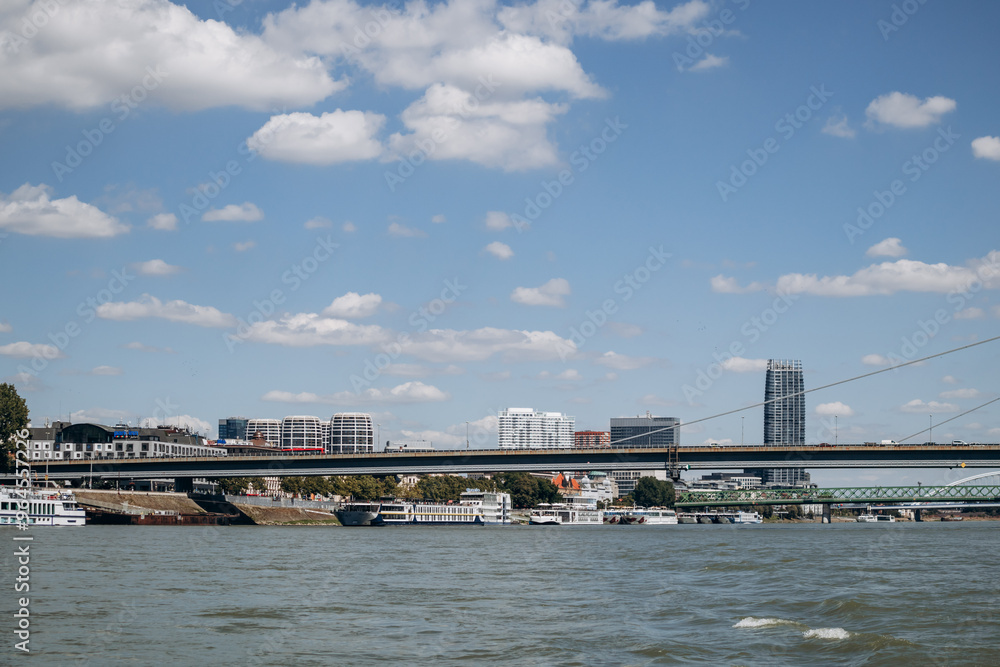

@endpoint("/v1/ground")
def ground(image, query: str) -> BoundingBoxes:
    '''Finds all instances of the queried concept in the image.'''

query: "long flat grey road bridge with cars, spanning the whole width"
[11,444,1000,486]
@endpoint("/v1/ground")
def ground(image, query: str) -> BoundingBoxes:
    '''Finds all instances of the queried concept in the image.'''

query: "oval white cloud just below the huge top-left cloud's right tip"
[247,109,385,165]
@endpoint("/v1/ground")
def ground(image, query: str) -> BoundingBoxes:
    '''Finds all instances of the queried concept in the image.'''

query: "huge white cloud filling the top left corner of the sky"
[0,0,342,111]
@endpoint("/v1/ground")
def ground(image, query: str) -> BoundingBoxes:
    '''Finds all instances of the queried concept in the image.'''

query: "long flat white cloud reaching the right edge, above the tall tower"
[777,250,1000,297]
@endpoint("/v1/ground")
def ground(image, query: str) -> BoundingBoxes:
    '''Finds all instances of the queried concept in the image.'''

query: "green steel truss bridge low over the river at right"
[675,485,1000,509]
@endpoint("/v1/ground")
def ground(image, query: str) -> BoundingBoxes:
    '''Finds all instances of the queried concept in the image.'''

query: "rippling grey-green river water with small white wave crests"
[7,522,1000,667]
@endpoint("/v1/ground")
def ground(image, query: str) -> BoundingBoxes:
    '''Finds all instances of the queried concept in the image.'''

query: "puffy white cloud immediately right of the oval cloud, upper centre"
[387,83,568,171]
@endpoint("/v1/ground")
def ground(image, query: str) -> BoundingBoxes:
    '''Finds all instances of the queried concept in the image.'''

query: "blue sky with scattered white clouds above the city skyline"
[0,0,1000,483]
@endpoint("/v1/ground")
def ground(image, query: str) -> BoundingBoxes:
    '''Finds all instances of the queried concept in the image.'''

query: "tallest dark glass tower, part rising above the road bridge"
[764,359,806,445]
